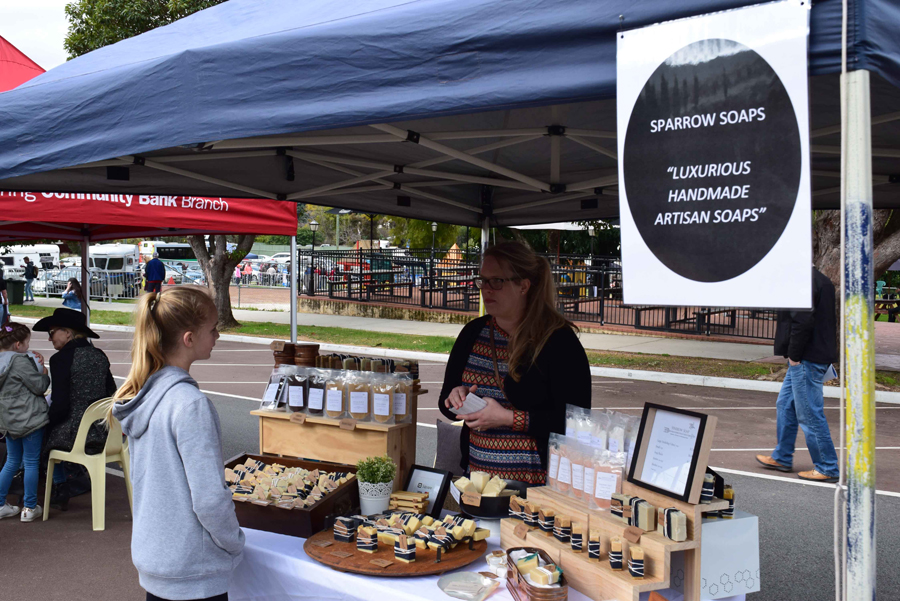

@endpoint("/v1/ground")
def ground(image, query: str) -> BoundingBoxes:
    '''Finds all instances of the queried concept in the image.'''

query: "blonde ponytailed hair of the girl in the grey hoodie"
[115,286,216,402]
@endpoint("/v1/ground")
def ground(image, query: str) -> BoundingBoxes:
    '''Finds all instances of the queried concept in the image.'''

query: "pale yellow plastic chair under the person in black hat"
[44,398,134,531]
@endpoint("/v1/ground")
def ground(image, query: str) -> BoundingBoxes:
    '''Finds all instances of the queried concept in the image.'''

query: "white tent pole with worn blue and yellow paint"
[841,70,875,601]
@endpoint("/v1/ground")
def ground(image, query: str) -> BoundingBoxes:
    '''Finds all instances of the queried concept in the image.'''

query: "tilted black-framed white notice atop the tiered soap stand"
[628,403,716,504]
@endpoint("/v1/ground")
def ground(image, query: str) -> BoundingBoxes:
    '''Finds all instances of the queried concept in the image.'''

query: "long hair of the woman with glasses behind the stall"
[484,242,578,382]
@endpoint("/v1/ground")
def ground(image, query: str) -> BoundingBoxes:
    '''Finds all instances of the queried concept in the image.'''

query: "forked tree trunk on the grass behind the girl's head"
[189,235,256,329]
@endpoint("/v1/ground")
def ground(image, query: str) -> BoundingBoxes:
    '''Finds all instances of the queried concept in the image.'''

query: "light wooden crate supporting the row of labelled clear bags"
[250,403,416,490]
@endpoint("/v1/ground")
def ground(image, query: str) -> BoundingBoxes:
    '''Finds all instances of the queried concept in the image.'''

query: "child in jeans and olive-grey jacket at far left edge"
[0,322,50,522]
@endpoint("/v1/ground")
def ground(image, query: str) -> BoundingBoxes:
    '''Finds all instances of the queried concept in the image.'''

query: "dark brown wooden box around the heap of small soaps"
[225,454,359,538]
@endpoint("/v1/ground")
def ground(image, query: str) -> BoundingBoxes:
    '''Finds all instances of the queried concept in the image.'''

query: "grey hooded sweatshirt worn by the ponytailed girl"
[113,366,244,600]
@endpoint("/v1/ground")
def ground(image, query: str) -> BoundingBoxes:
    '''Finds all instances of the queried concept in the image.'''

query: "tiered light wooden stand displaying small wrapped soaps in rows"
[500,482,728,601]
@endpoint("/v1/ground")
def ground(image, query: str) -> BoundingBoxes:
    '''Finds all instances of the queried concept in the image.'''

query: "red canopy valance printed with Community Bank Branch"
[0,192,297,241]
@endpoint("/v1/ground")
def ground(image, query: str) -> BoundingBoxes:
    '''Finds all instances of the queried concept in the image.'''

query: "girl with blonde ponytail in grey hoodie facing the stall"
[112,286,244,601]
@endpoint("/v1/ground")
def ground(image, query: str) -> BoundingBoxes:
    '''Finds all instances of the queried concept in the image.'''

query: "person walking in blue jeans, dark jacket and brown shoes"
[756,268,840,482]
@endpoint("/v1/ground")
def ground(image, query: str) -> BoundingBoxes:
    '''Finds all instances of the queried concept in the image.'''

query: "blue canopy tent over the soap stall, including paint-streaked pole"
[0,0,900,599]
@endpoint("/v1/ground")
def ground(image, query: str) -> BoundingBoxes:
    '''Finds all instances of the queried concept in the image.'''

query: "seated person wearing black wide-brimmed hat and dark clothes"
[32,308,116,511]
